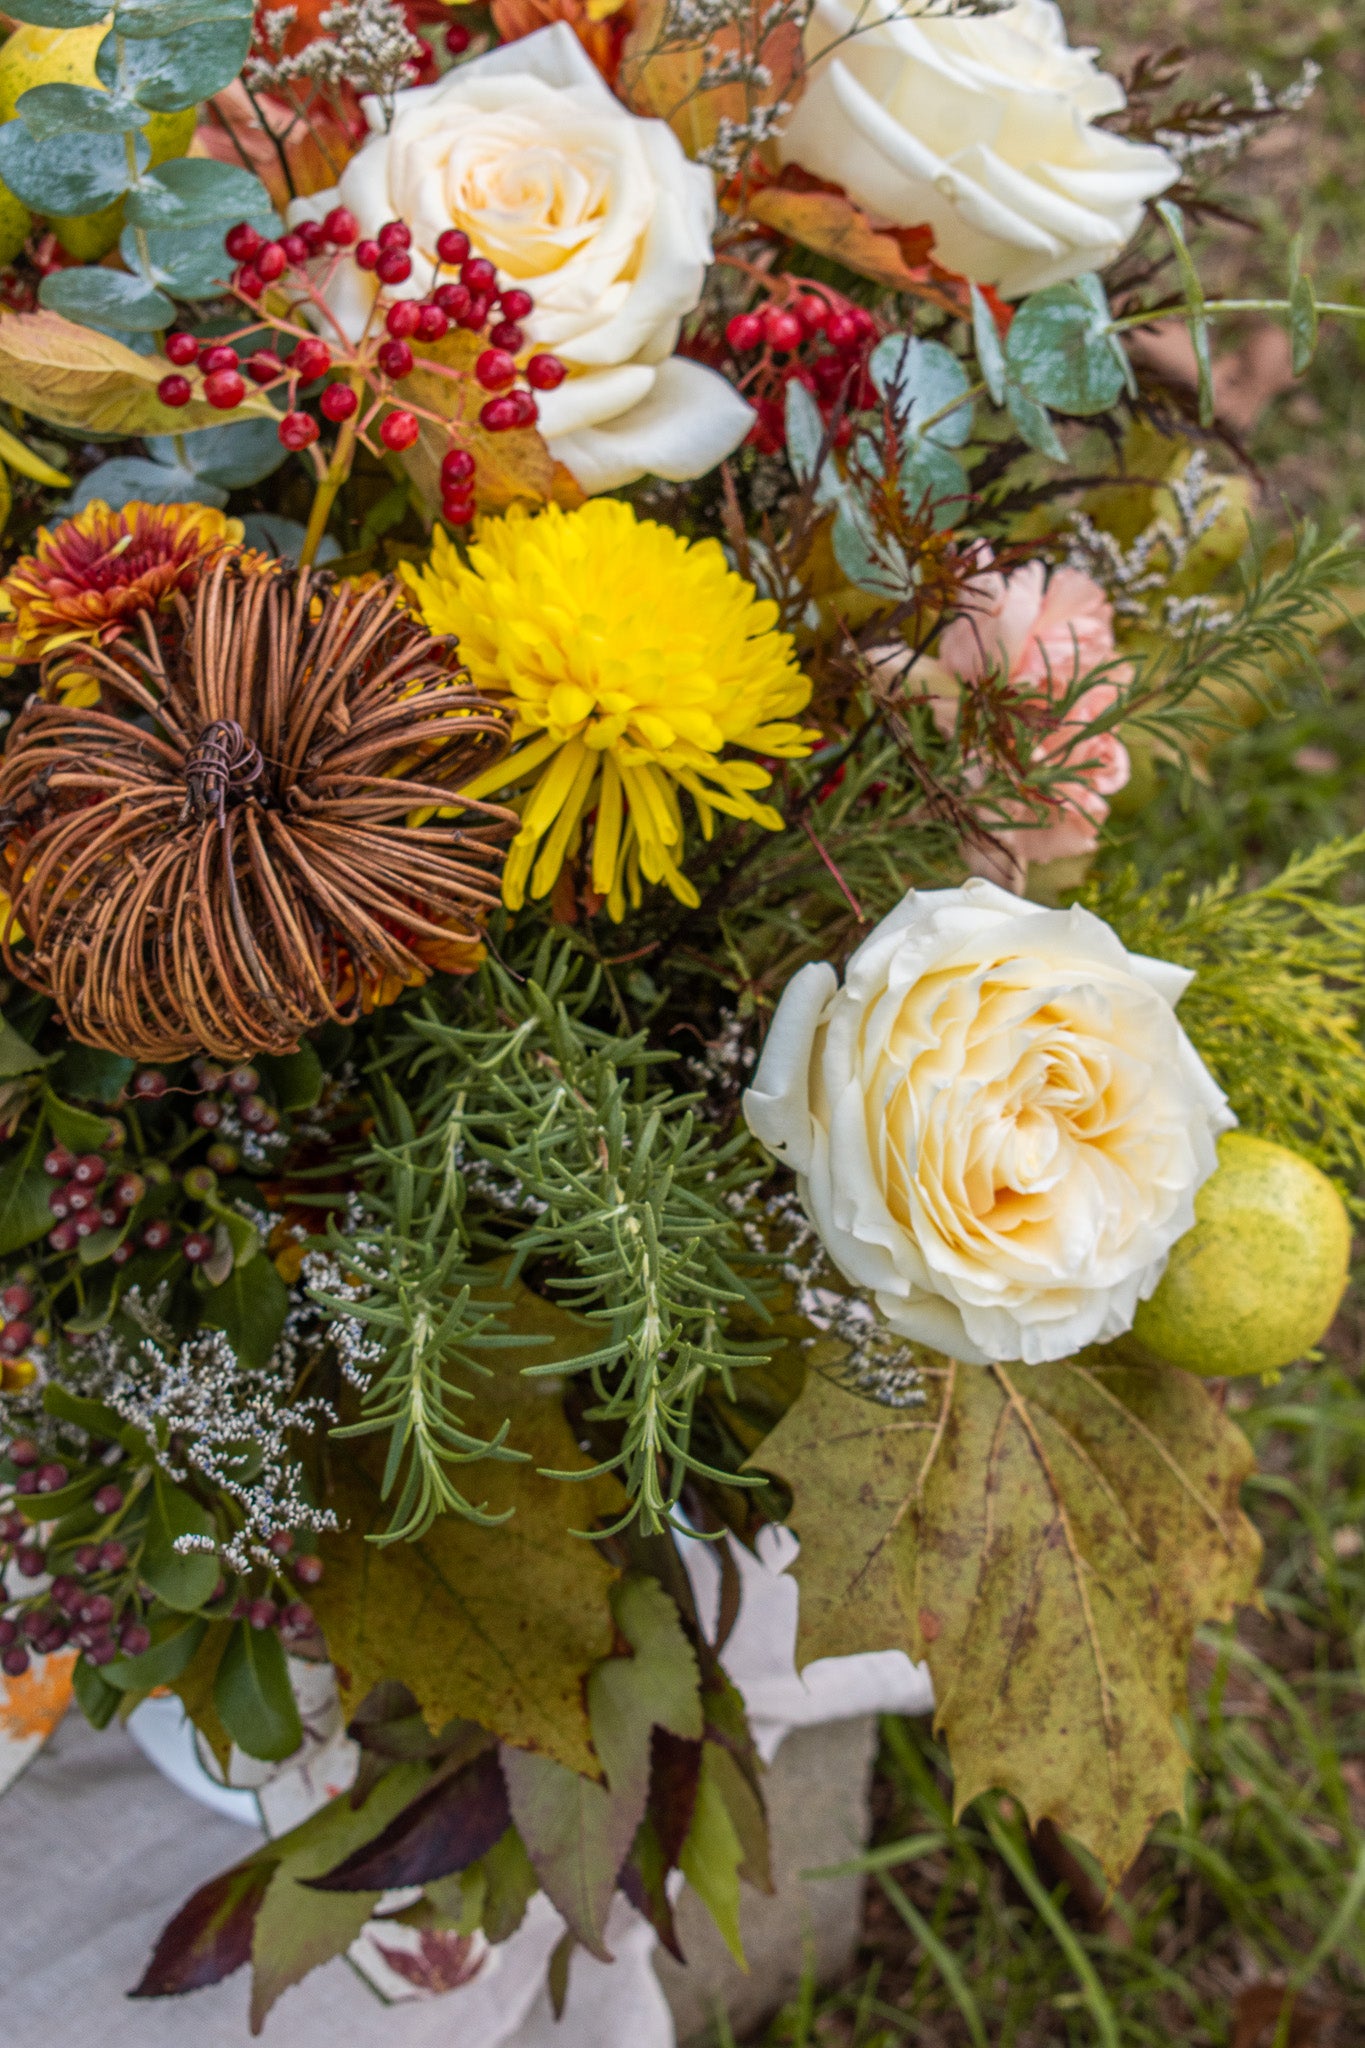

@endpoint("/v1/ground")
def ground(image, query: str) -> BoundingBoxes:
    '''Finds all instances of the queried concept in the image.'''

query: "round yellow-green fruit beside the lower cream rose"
[1132,1130,1351,1376]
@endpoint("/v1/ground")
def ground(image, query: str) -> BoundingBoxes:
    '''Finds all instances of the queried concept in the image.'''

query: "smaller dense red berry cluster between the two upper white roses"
[724,287,880,455]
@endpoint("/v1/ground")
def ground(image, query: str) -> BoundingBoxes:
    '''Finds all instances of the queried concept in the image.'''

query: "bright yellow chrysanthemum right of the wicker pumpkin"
[403,498,819,920]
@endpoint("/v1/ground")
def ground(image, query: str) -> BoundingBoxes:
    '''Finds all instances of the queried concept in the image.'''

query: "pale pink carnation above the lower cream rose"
[939,561,1132,891]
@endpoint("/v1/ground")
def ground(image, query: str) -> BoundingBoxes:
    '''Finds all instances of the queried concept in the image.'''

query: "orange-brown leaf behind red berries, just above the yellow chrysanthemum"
[403,328,583,512]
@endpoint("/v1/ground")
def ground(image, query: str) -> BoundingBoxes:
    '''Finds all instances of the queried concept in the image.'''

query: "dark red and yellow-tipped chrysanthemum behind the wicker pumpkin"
[0,498,241,668]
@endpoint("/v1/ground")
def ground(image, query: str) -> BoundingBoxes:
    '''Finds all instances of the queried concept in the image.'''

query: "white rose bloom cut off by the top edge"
[778,0,1179,297]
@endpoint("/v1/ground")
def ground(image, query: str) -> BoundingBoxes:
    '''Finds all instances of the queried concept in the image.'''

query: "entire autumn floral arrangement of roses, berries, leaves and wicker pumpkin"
[0,0,1365,2025]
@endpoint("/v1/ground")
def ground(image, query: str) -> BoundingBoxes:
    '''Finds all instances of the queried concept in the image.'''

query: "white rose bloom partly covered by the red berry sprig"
[289,23,753,492]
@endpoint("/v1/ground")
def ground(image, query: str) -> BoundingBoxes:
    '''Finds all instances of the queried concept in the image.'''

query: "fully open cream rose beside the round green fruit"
[745,881,1236,1364]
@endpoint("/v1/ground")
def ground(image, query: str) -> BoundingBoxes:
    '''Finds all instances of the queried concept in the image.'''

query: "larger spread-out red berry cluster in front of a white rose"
[158,207,565,526]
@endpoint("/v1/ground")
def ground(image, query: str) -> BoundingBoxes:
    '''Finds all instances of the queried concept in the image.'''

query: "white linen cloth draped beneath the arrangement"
[0,1530,933,2048]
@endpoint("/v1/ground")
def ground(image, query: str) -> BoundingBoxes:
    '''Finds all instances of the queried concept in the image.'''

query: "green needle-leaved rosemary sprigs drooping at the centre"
[329,940,765,1540]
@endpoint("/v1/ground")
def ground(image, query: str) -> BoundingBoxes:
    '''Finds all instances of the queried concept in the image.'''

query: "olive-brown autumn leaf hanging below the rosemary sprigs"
[309,1286,624,1778]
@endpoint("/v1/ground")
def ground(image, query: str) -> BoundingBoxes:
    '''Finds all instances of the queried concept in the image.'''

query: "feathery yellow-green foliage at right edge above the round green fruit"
[1083,834,1365,1214]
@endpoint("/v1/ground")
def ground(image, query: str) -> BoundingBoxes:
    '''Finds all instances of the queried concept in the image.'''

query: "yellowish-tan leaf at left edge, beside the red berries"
[0,311,274,438]
